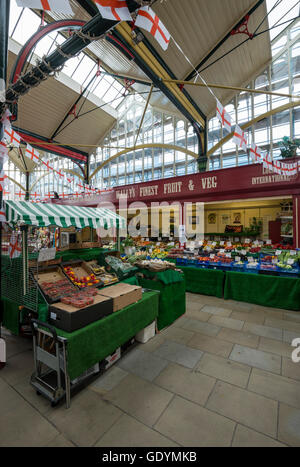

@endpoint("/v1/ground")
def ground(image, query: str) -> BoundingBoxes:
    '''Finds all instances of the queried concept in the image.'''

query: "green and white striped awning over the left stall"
[4,201,126,229]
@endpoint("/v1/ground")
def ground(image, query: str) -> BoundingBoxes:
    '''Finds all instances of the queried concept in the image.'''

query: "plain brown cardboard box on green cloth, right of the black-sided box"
[98,283,142,311]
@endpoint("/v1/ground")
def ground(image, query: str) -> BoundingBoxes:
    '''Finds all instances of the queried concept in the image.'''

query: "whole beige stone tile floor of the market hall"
[0,293,300,447]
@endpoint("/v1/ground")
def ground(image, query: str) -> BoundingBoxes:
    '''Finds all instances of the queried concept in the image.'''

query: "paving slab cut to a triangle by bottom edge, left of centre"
[95,414,178,448]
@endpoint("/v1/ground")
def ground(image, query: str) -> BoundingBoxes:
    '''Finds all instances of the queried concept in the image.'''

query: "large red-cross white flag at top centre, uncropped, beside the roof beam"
[134,6,171,50]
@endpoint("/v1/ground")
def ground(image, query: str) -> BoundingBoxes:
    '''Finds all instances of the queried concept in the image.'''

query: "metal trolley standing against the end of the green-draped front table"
[30,319,71,408]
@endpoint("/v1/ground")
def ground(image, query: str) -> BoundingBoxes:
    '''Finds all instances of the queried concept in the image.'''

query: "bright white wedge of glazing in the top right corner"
[267,0,299,41]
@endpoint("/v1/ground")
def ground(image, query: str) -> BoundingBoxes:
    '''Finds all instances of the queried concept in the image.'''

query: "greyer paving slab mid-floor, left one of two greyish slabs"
[153,341,203,370]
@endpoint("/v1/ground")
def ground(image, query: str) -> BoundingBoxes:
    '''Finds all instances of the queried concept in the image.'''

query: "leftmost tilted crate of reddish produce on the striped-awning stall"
[34,266,78,304]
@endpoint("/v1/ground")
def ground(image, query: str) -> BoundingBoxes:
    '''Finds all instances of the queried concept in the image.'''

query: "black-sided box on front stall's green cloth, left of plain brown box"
[49,295,113,332]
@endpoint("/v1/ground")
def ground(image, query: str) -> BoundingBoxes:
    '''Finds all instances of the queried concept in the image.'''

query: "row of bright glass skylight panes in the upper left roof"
[9,0,125,109]
